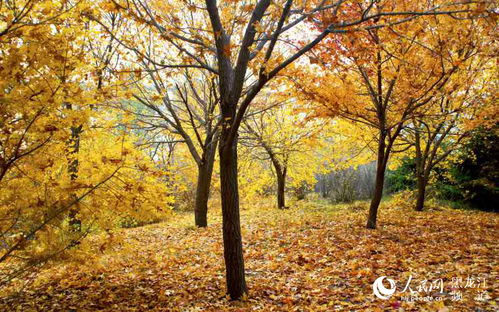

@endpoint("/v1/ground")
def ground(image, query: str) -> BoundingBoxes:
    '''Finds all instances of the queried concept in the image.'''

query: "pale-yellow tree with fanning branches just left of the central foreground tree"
[91,3,220,227]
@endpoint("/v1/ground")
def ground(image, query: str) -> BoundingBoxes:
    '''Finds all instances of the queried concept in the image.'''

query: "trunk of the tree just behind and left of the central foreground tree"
[194,143,216,227]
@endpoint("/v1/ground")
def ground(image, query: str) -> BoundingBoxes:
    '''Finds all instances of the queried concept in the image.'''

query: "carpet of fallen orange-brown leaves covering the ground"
[0,202,499,312]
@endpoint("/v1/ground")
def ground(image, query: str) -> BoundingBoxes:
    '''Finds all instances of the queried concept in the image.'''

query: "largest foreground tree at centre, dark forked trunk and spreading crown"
[99,0,486,299]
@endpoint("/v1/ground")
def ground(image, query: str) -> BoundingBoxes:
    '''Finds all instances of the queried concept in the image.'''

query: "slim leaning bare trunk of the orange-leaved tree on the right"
[366,135,388,229]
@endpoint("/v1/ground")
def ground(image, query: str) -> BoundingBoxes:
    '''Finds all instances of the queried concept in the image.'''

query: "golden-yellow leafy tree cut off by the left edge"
[0,1,96,282]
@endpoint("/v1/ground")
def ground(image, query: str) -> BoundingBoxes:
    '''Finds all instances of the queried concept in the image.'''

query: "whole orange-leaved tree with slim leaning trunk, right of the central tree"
[294,4,490,229]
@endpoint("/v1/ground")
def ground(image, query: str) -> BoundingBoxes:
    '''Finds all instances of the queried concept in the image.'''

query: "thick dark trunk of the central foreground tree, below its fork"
[219,132,247,300]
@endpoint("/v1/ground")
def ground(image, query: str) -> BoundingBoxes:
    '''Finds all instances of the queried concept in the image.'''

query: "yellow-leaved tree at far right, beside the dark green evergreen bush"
[401,53,497,211]
